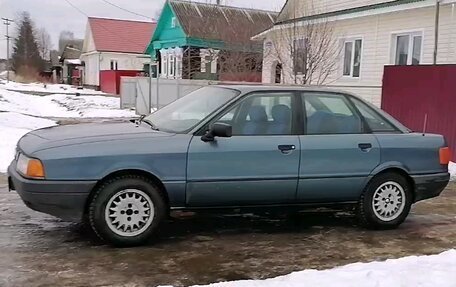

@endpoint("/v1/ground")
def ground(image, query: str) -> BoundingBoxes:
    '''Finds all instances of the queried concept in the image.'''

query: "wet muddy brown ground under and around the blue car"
[0,176,456,287]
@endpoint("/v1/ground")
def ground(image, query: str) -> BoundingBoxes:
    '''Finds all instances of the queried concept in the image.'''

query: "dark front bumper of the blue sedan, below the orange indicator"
[8,162,96,222]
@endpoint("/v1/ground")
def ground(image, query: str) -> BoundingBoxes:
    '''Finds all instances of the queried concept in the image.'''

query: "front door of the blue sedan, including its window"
[186,92,300,207]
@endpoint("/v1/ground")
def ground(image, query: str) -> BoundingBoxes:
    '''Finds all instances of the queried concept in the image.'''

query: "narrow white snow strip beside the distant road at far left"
[2,82,104,95]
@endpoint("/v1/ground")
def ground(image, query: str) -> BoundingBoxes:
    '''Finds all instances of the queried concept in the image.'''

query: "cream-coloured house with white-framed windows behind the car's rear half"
[255,0,456,106]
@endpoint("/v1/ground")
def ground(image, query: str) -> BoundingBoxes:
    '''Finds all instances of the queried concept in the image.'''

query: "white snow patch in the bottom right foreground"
[188,250,456,287]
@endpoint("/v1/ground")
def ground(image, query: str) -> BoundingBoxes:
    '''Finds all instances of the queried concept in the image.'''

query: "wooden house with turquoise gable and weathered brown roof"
[147,0,277,81]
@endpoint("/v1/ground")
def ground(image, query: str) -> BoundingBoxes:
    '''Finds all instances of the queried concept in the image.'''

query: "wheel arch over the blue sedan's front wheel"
[84,169,170,216]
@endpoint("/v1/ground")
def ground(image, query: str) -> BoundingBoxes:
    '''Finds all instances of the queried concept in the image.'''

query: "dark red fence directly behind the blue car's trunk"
[382,65,456,161]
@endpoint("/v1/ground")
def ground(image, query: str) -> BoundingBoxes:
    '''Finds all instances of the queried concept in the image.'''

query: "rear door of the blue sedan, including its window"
[297,92,380,202]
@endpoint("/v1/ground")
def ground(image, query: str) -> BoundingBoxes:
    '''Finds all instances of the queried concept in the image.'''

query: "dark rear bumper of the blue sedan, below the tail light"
[412,173,450,202]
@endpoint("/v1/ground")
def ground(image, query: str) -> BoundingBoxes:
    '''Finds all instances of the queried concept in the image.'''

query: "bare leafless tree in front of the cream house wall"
[265,0,342,85]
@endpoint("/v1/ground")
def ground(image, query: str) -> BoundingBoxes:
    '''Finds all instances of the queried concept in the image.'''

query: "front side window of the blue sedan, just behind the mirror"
[216,93,293,136]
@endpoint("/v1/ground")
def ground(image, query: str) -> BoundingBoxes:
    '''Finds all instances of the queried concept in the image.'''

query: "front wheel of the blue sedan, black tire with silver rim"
[88,175,167,247]
